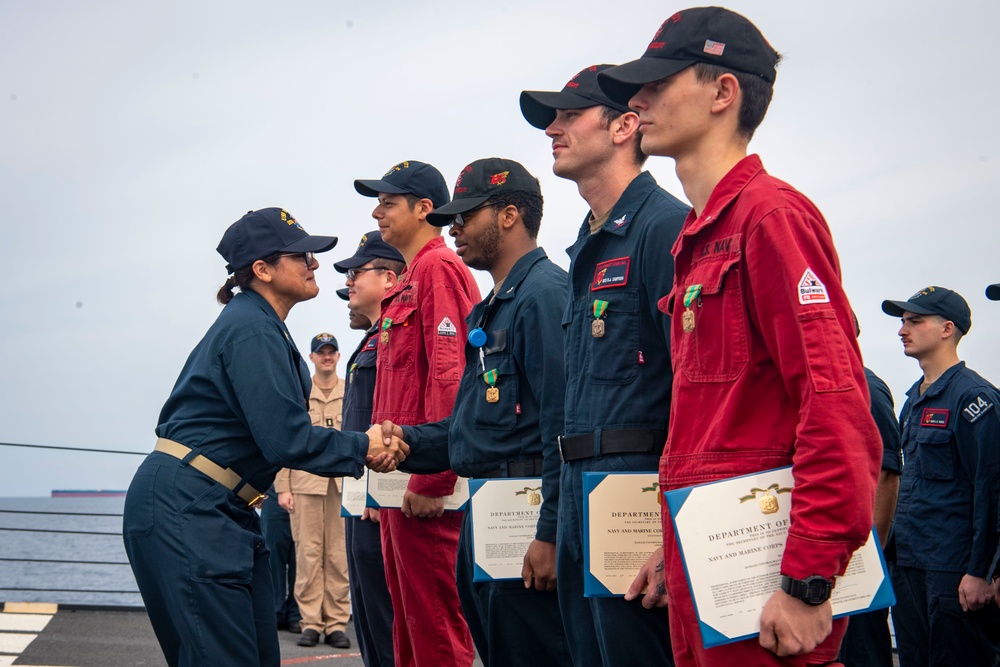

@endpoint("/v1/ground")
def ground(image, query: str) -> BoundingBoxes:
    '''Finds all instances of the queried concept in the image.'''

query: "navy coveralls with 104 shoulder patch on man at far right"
[893,362,1000,667]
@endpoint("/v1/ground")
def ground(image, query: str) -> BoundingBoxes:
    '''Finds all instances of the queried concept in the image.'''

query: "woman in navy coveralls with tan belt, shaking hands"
[123,208,405,667]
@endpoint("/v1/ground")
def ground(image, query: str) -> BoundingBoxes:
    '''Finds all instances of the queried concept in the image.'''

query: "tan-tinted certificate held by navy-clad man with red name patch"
[583,472,663,597]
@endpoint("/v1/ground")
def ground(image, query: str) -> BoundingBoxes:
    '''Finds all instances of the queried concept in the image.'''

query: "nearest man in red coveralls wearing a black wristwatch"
[598,7,881,666]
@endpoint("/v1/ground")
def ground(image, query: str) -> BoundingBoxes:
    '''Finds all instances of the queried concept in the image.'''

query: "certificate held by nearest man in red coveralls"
[664,467,896,648]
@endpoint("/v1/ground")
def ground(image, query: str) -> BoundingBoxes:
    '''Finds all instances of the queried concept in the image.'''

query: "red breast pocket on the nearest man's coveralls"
[675,254,750,382]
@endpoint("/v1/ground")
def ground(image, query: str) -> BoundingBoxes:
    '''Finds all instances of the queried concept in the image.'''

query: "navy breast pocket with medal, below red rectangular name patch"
[576,287,640,384]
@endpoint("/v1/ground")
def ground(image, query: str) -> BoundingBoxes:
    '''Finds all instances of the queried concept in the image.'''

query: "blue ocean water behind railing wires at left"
[0,497,142,607]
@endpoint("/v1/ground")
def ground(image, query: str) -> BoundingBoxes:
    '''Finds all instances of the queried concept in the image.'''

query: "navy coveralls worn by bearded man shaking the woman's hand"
[402,248,569,666]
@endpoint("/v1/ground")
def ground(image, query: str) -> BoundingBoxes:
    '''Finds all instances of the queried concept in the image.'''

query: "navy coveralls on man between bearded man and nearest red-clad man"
[557,172,688,665]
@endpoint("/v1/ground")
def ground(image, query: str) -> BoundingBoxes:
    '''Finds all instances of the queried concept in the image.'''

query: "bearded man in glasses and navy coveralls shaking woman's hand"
[394,158,571,667]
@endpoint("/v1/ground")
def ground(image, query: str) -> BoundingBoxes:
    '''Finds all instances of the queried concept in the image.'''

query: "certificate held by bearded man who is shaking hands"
[469,477,542,581]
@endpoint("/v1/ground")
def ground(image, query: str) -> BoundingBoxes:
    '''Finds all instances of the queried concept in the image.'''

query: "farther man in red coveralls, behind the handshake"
[354,160,481,667]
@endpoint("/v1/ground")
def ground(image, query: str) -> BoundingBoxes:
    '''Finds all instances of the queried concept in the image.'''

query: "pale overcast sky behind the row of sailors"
[0,0,1000,496]
